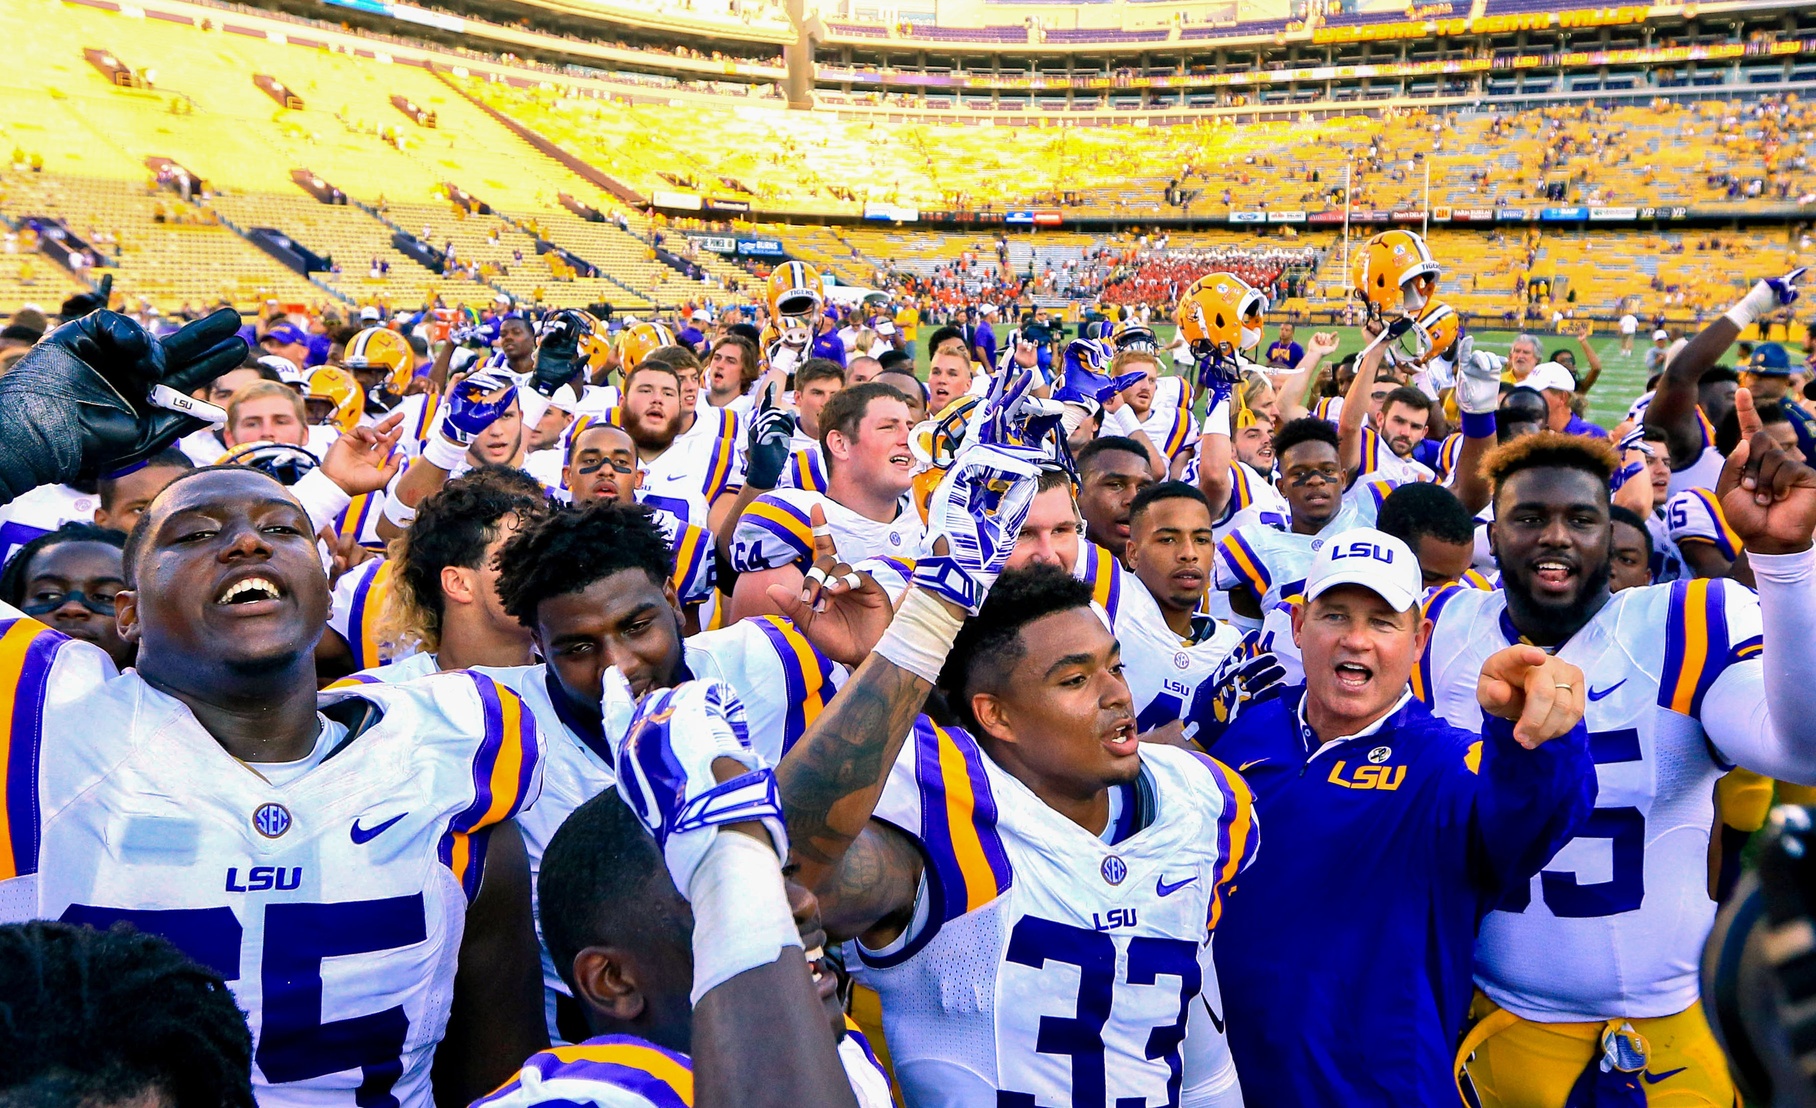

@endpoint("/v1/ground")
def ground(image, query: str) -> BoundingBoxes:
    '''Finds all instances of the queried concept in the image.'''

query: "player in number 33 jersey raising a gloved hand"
[777,426,1257,1104]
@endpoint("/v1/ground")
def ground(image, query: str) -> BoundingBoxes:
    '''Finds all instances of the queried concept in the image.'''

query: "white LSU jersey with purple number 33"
[859,717,1258,1108]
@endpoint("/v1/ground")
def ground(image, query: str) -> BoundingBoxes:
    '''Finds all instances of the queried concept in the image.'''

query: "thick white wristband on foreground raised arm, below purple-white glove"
[685,828,801,1004]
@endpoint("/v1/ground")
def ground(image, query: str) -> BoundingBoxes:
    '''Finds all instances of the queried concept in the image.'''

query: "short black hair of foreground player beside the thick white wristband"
[536,788,686,988]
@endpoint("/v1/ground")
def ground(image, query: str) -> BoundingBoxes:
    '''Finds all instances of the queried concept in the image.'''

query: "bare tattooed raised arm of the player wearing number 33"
[775,654,933,946]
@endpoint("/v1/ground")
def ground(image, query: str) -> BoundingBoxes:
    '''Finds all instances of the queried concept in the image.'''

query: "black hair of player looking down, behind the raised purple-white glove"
[498,503,676,628]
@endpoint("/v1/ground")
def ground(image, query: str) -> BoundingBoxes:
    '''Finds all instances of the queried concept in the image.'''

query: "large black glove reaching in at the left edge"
[0,309,245,503]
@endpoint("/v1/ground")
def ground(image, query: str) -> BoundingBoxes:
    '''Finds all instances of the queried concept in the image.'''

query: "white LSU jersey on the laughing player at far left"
[0,607,541,1108]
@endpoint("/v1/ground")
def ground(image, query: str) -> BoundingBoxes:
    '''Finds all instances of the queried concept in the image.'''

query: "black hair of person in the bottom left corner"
[0,921,254,1108]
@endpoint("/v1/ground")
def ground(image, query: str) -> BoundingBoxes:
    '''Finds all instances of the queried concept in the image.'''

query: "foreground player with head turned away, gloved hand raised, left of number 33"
[474,681,868,1108]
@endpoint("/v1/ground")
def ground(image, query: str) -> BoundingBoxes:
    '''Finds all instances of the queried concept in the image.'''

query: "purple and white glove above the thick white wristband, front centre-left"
[599,667,788,901]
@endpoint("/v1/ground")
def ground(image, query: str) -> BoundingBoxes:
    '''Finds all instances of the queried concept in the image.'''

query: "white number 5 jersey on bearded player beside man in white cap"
[1413,579,1762,1023]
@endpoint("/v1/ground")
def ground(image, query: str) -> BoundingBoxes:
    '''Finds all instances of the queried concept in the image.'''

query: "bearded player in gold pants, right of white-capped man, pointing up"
[1415,414,1816,1106]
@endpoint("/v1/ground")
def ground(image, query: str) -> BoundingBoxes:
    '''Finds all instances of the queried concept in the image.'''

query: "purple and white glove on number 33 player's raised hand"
[913,440,1046,616]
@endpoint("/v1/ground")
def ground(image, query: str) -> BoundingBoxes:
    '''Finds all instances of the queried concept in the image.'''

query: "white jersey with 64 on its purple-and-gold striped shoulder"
[732,489,924,574]
